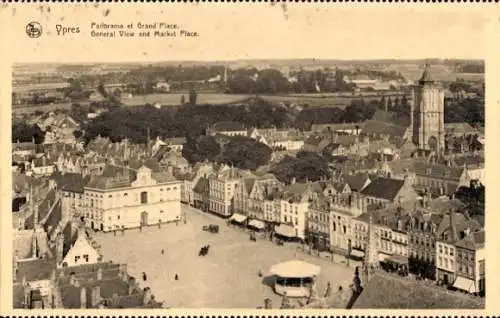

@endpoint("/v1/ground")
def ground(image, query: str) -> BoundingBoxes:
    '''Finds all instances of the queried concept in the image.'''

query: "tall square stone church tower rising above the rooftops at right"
[411,65,445,155]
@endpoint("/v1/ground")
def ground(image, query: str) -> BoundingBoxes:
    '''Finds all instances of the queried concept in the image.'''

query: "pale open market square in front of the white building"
[95,206,354,308]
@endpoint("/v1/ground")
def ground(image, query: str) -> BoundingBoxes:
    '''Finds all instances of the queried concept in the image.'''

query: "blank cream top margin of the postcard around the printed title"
[3,3,488,62]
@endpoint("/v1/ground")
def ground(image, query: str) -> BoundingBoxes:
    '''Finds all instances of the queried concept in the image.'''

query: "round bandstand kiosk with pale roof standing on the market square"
[270,260,321,297]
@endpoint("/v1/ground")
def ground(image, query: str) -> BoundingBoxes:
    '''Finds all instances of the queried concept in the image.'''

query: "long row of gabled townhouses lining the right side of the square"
[178,165,484,293]
